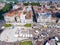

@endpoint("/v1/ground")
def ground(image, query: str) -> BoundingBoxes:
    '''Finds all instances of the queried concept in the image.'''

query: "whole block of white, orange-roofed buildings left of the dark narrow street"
[4,6,32,23]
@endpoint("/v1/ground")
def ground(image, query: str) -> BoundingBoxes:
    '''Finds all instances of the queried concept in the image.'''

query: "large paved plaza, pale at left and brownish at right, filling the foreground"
[0,23,60,45]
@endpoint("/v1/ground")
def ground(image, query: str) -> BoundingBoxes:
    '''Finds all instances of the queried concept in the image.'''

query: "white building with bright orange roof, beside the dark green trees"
[4,10,20,22]
